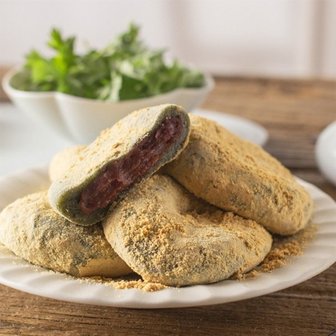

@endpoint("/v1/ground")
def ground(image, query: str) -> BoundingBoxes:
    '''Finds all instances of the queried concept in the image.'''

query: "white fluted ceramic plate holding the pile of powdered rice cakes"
[0,168,336,308]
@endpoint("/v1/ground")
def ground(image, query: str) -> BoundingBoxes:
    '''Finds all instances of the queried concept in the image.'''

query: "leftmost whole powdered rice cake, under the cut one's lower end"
[0,191,132,277]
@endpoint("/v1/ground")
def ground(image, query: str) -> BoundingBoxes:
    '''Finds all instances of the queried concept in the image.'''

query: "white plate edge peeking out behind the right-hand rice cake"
[193,109,268,146]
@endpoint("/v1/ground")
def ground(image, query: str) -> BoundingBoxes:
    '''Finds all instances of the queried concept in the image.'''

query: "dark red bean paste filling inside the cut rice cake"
[79,116,183,215]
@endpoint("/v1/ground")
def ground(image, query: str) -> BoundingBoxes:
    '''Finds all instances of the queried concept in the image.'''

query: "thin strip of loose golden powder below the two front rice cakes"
[80,274,168,292]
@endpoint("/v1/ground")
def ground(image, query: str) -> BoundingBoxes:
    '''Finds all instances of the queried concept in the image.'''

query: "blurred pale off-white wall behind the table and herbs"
[0,0,336,78]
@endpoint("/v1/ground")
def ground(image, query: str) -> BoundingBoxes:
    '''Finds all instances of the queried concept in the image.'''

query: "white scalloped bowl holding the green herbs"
[2,68,214,144]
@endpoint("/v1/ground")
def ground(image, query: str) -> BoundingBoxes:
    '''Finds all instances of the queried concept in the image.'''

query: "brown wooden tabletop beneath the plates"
[0,78,336,336]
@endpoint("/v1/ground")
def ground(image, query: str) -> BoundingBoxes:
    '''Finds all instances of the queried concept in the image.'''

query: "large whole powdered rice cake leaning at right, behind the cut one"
[163,114,313,235]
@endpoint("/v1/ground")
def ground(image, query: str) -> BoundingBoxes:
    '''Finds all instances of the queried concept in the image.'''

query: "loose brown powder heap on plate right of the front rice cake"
[232,224,317,280]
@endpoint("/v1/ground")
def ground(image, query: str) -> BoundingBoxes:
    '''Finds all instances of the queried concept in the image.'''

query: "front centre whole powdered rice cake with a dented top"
[103,175,272,286]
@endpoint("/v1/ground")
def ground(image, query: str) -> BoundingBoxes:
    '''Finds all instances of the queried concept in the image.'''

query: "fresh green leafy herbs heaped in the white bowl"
[11,24,204,101]
